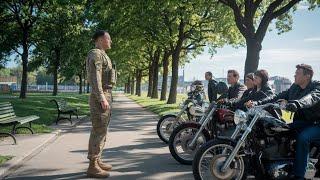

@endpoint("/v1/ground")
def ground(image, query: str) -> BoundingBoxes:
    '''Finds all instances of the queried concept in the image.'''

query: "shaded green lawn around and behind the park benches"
[0,93,89,133]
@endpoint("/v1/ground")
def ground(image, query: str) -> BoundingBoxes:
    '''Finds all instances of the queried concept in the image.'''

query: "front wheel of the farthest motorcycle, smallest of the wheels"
[157,114,181,143]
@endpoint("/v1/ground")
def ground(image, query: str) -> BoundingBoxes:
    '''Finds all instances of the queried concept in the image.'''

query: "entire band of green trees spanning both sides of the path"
[0,0,320,104]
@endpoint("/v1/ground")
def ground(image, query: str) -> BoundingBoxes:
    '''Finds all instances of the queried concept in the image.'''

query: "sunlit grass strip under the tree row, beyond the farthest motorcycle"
[126,93,187,116]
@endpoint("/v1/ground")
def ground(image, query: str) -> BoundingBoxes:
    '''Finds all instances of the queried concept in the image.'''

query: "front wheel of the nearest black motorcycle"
[193,140,246,180]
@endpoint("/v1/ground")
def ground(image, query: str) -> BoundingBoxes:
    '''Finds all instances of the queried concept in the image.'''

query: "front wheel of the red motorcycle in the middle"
[169,123,210,165]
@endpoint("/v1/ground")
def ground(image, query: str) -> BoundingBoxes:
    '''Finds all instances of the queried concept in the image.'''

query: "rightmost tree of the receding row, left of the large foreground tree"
[160,0,240,104]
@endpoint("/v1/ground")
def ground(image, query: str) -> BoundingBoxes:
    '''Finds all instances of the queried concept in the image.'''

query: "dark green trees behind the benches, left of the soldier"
[0,0,91,98]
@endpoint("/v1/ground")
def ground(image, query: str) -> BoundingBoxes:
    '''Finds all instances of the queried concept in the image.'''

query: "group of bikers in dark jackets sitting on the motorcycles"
[205,64,320,180]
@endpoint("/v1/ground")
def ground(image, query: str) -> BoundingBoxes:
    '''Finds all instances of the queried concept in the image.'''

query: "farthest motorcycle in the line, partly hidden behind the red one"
[157,91,209,143]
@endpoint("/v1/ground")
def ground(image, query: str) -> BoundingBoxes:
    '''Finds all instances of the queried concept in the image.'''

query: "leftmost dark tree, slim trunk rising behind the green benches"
[0,0,47,98]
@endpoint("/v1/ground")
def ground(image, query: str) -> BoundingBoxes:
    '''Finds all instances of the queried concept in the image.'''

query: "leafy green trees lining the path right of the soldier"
[100,0,319,104]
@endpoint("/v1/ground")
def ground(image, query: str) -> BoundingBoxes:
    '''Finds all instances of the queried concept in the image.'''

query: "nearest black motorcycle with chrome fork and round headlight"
[193,104,320,180]
